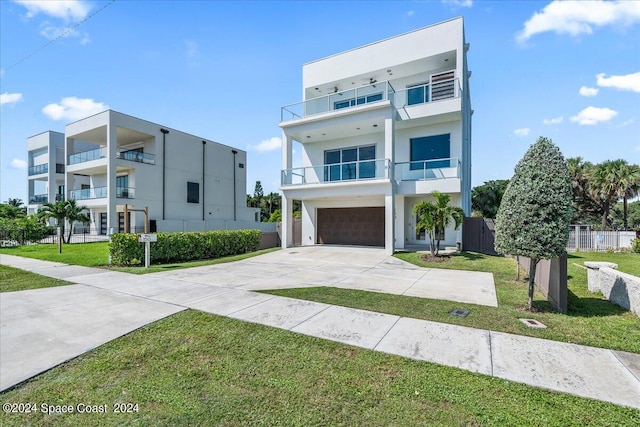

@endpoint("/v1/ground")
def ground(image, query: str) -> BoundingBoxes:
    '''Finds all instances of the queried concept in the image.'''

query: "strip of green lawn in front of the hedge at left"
[0,242,279,274]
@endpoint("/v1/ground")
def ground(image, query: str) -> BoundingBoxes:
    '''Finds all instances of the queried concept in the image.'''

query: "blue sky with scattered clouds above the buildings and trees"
[0,0,640,201]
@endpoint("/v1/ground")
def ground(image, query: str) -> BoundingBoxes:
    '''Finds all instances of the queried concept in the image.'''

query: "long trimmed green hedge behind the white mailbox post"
[109,230,262,265]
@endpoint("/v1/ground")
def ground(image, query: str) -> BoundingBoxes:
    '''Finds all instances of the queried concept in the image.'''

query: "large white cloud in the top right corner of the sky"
[516,0,640,42]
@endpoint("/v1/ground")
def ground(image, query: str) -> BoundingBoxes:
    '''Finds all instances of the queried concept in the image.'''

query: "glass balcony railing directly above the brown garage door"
[281,159,390,186]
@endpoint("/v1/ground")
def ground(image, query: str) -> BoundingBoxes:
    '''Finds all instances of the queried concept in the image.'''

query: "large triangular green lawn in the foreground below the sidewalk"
[0,311,640,427]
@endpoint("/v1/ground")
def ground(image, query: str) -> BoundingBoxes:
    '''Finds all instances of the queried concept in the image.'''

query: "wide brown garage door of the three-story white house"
[316,208,384,246]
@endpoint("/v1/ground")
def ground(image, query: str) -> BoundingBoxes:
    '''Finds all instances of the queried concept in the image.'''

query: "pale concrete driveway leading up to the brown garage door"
[146,246,498,307]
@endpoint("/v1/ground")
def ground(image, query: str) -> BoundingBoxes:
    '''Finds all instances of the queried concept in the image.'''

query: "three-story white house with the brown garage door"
[280,18,472,253]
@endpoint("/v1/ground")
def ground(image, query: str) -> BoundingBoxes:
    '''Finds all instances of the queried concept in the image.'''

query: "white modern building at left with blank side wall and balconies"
[27,110,260,234]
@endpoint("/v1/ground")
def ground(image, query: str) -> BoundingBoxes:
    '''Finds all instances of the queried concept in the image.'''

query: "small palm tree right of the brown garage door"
[413,191,464,256]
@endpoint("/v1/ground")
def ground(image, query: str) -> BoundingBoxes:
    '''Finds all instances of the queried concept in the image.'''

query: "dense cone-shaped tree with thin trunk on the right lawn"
[495,137,573,310]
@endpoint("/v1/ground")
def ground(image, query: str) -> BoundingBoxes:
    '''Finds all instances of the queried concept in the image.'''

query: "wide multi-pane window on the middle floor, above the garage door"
[324,145,376,181]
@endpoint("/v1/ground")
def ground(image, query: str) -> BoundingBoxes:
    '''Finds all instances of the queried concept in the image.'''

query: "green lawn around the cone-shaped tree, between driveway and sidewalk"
[265,252,640,353]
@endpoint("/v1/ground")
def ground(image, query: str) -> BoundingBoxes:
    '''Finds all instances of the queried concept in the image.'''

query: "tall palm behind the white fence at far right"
[588,159,628,230]
